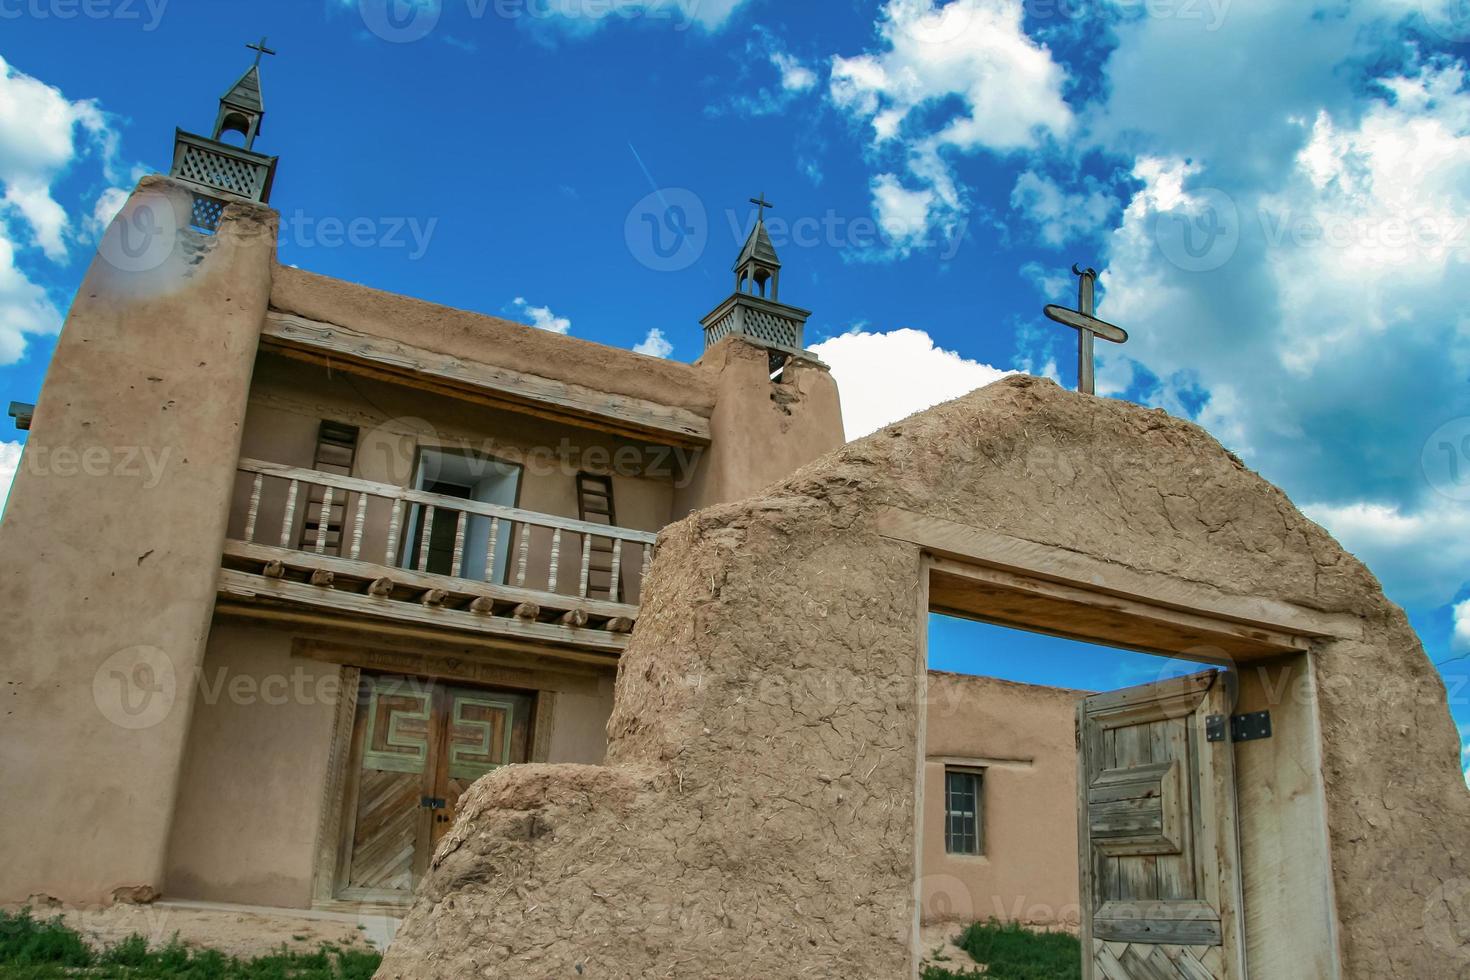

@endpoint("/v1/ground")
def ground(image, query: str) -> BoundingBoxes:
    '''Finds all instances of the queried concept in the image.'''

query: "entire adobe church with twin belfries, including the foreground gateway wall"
[0,51,1470,980]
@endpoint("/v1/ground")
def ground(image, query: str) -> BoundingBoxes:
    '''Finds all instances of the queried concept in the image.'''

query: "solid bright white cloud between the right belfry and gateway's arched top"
[811,328,1014,439]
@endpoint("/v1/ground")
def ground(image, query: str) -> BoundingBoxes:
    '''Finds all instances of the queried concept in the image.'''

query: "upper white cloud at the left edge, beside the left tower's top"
[0,57,116,262]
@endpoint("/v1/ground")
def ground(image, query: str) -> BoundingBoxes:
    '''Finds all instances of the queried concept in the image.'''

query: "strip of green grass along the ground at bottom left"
[0,908,382,980]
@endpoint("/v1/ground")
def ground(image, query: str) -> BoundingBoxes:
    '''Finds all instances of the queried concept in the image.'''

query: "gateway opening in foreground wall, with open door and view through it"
[914,557,1336,980]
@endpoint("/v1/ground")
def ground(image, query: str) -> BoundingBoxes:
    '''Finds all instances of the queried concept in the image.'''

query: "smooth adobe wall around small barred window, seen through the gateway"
[919,671,1086,929]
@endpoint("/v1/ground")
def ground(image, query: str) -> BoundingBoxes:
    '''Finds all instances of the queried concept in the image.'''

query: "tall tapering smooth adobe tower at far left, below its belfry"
[0,178,276,902]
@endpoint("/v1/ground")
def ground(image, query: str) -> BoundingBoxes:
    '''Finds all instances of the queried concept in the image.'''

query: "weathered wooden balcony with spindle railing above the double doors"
[219,460,657,661]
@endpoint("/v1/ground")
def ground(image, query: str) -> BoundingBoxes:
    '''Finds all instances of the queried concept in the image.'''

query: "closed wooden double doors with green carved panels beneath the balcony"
[338,674,532,902]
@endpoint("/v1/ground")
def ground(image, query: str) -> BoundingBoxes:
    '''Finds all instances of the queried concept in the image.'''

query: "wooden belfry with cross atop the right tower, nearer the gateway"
[700,194,811,370]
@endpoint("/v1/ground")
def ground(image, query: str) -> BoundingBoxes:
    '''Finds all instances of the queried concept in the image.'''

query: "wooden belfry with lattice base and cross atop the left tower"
[169,38,279,232]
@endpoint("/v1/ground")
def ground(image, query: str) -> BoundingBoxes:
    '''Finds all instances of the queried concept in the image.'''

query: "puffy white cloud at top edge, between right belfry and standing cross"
[829,0,1073,245]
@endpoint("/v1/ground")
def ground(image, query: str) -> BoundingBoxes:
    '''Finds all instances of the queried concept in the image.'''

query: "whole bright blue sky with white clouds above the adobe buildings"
[0,0,1470,769]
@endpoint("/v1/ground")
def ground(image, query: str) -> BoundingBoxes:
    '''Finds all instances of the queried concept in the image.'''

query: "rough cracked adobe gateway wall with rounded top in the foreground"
[379,378,1470,980]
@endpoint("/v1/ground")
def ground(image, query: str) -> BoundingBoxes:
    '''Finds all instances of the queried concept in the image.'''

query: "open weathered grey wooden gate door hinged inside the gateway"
[1078,671,1245,980]
